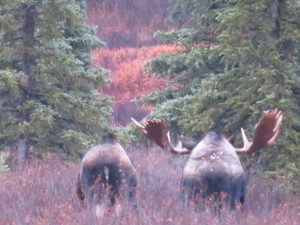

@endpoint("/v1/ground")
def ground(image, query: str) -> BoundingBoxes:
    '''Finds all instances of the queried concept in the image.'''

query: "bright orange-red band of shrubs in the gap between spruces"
[93,45,177,104]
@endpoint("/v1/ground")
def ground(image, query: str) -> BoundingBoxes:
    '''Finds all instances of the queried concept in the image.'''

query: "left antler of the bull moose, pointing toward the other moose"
[131,117,191,154]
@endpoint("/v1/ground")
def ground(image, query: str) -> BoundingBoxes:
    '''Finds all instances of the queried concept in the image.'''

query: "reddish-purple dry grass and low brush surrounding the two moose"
[0,149,300,225]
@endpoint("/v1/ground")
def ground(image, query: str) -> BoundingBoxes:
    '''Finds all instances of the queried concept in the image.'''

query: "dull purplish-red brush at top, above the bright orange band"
[87,0,171,47]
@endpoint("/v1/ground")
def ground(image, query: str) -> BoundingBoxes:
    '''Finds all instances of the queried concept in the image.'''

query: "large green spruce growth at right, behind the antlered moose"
[144,0,300,188]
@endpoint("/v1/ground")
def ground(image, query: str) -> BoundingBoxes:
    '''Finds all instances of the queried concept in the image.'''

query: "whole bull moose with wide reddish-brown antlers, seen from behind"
[131,109,282,209]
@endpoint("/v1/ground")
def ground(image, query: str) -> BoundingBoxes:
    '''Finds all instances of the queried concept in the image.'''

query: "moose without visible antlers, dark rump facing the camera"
[77,133,138,213]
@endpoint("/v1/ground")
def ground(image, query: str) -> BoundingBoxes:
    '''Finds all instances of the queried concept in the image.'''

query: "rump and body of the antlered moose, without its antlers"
[181,131,246,209]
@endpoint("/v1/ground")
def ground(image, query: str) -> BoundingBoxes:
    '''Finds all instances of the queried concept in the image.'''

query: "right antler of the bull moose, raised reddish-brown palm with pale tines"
[236,109,282,154]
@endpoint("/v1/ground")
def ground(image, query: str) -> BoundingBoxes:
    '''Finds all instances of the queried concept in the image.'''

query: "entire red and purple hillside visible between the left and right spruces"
[87,0,176,124]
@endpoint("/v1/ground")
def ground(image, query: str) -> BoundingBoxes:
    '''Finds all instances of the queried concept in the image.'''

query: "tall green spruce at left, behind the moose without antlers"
[0,0,111,159]
